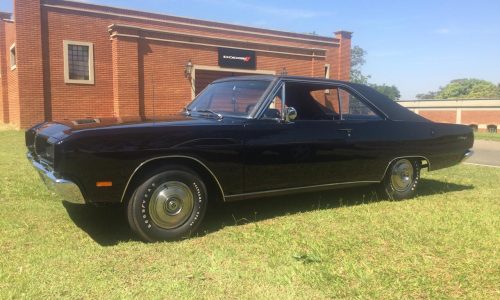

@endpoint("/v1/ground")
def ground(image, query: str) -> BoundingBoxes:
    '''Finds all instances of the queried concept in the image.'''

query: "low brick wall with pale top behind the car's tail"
[398,99,500,132]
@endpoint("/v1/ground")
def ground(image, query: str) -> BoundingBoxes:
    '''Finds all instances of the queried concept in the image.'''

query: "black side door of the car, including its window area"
[240,83,354,193]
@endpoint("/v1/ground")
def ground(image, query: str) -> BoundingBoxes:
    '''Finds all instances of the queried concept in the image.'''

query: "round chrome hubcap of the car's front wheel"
[149,181,194,229]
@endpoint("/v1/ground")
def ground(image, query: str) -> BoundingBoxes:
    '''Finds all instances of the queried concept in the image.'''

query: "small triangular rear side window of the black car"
[339,89,382,120]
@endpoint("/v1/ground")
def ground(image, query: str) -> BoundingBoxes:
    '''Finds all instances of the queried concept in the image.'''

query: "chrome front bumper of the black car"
[27,153,85,204]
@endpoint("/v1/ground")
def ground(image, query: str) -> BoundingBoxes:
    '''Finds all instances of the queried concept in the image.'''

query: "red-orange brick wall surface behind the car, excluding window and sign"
[0,0,351,127]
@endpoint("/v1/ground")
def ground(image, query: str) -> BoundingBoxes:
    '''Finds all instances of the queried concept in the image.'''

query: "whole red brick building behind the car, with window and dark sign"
[0,0,351,128]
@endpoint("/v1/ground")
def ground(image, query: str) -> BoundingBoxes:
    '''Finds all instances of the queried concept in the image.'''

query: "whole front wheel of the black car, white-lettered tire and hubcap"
[127,168,208,242]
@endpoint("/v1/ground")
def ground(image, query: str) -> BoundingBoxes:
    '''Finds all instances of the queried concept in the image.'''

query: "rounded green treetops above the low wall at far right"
[416,78,500,99]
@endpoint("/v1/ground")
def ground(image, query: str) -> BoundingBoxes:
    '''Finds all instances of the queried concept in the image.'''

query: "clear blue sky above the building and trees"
[0,0,500,99]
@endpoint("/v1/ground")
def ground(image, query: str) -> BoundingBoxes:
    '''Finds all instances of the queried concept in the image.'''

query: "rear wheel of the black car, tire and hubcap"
[380,158,421,200]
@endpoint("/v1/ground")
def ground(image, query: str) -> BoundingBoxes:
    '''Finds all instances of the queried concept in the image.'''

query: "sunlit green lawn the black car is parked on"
[0,130,500,299]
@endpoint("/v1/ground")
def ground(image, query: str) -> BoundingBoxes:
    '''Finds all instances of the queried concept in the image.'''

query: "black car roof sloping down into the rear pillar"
[214,75,429,122]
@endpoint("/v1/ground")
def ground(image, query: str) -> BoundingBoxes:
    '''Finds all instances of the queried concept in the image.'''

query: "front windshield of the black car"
[187,80,271,117]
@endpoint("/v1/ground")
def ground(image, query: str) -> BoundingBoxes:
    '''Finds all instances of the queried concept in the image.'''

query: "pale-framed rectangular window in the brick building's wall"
[63,41,94,84]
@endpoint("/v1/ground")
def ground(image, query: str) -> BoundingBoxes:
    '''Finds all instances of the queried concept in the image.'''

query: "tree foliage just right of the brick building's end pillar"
[351,46,401,100]
